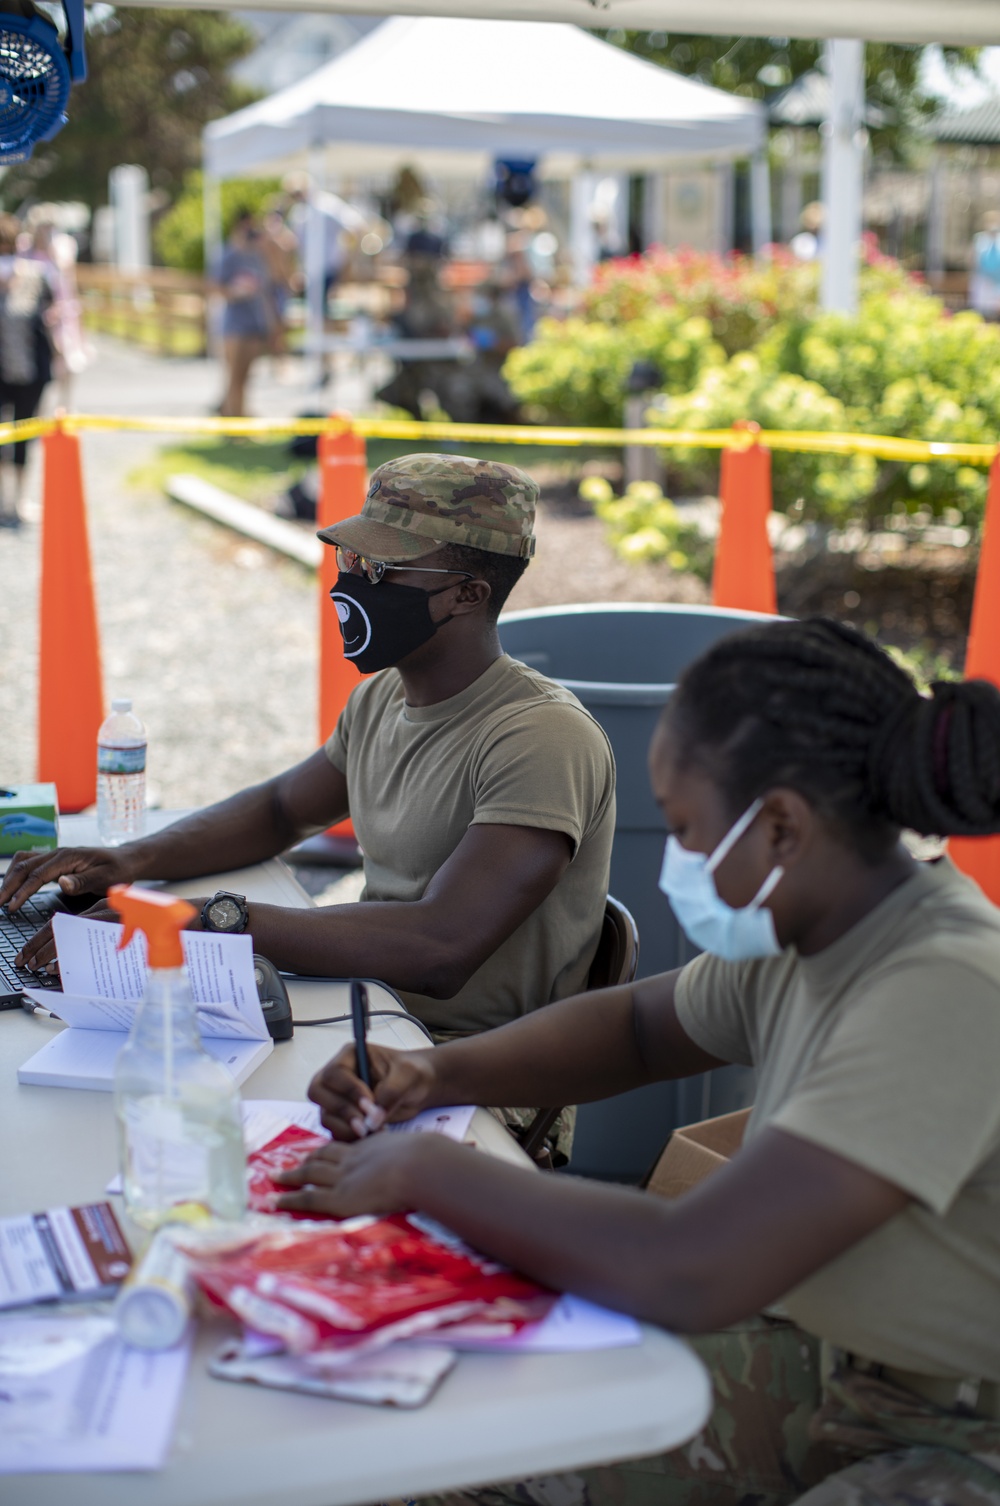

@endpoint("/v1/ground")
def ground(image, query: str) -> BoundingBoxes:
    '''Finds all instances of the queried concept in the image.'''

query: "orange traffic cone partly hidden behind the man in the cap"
[316,429,367,837]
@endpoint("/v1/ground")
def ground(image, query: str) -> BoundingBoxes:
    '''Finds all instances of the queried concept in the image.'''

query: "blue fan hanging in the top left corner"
[0,0,87,166]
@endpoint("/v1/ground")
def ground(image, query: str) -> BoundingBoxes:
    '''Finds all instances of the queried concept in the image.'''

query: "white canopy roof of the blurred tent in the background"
[203,17,767,178]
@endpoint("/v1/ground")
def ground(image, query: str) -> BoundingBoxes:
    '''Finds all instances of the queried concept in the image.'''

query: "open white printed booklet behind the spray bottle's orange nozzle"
[18,914,274,1092]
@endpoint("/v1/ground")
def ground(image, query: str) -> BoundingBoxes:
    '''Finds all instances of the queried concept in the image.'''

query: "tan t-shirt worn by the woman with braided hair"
[676,858,1000,1381]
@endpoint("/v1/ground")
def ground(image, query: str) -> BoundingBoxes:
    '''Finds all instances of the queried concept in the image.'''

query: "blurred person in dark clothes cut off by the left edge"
[0,214,56,529]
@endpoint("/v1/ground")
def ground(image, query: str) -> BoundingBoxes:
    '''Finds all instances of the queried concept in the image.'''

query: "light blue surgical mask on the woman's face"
[660,800,785,962]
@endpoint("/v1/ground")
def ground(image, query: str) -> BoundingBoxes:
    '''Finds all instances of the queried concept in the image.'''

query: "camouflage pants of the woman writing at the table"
[422,1318,1000,1506]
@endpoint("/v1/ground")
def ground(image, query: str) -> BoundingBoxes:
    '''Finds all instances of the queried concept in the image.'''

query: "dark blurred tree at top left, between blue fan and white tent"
[0,6,256,208]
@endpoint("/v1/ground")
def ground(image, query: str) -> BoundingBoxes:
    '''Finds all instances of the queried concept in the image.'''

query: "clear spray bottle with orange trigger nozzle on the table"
[108,884,247,1229]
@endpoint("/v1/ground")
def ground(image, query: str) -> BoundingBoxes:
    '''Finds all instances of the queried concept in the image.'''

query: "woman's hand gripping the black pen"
[309,1045,438,1140]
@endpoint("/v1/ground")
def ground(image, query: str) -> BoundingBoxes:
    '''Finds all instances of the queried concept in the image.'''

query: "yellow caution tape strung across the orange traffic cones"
[0,413,998,465]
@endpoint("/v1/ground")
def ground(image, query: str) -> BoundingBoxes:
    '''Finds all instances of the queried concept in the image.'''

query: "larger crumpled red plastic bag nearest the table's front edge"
[191,1214,556,1354]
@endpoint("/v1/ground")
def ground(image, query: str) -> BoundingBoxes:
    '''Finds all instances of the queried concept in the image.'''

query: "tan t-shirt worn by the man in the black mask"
[327,655,614,1032]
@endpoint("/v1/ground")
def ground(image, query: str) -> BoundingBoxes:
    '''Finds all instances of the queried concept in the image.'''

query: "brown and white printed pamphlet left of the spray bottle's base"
[0,1203,133,1309]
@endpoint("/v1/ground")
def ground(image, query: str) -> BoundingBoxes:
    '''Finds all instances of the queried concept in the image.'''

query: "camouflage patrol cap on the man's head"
[319,455,538,565]
